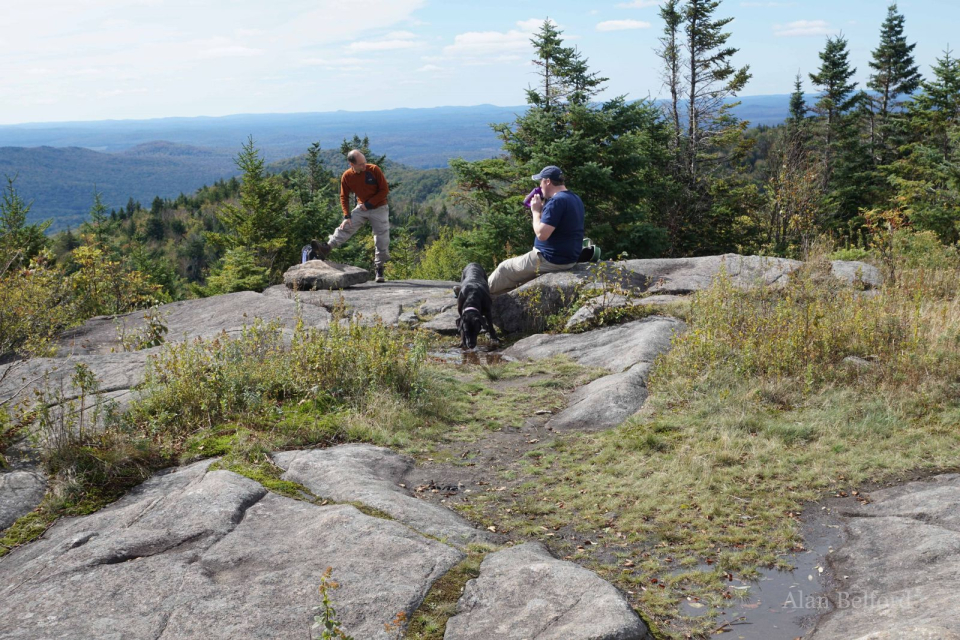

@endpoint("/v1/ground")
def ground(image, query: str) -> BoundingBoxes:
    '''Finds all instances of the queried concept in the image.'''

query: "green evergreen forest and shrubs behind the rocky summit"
[0,0,960,360]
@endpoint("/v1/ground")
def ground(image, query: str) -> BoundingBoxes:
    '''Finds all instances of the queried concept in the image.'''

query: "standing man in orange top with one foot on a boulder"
[310,149,390,282]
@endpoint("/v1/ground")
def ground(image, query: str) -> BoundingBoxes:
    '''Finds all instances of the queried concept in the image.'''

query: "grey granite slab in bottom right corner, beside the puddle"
[810,474,960,640]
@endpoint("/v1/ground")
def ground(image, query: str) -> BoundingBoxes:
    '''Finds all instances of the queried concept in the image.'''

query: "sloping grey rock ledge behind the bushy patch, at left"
[59,291,330,356]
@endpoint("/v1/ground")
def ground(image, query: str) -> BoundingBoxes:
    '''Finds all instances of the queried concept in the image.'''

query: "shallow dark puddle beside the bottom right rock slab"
[681,521,841,640]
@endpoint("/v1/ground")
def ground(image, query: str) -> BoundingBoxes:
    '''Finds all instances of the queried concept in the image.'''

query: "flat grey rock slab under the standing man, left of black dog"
[263,280,457,326]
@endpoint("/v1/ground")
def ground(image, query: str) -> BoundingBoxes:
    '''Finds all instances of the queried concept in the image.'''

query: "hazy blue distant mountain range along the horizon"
[0,95,789,229]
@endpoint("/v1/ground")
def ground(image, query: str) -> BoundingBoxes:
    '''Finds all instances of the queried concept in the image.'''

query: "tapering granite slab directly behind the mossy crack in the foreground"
[273,444,496,545]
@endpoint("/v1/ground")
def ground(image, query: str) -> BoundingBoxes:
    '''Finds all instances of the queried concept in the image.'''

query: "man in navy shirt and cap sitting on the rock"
[488,165,584,295]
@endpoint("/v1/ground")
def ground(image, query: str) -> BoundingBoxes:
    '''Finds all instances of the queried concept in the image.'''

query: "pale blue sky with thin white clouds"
[0,0,960,124]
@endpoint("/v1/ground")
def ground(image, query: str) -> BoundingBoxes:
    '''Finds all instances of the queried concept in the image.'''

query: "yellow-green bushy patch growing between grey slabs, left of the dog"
[129,321,426,455]
